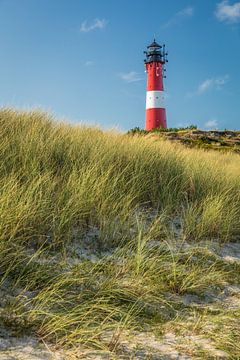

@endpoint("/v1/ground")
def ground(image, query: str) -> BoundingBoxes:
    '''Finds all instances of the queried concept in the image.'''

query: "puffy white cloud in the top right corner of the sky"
[215,0,240,23]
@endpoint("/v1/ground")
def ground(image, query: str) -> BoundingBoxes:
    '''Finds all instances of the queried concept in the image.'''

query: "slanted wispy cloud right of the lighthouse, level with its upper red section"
[186,74,229,98]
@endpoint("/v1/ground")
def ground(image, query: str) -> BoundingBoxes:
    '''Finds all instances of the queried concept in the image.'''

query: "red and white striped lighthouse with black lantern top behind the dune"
[144,39,168,130]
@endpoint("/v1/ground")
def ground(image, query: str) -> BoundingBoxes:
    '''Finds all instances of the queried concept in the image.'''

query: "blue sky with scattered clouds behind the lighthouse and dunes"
[0,0,240,130]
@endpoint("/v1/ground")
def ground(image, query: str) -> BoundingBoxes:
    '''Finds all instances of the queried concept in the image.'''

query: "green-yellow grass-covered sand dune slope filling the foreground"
[0,109,240,359]
